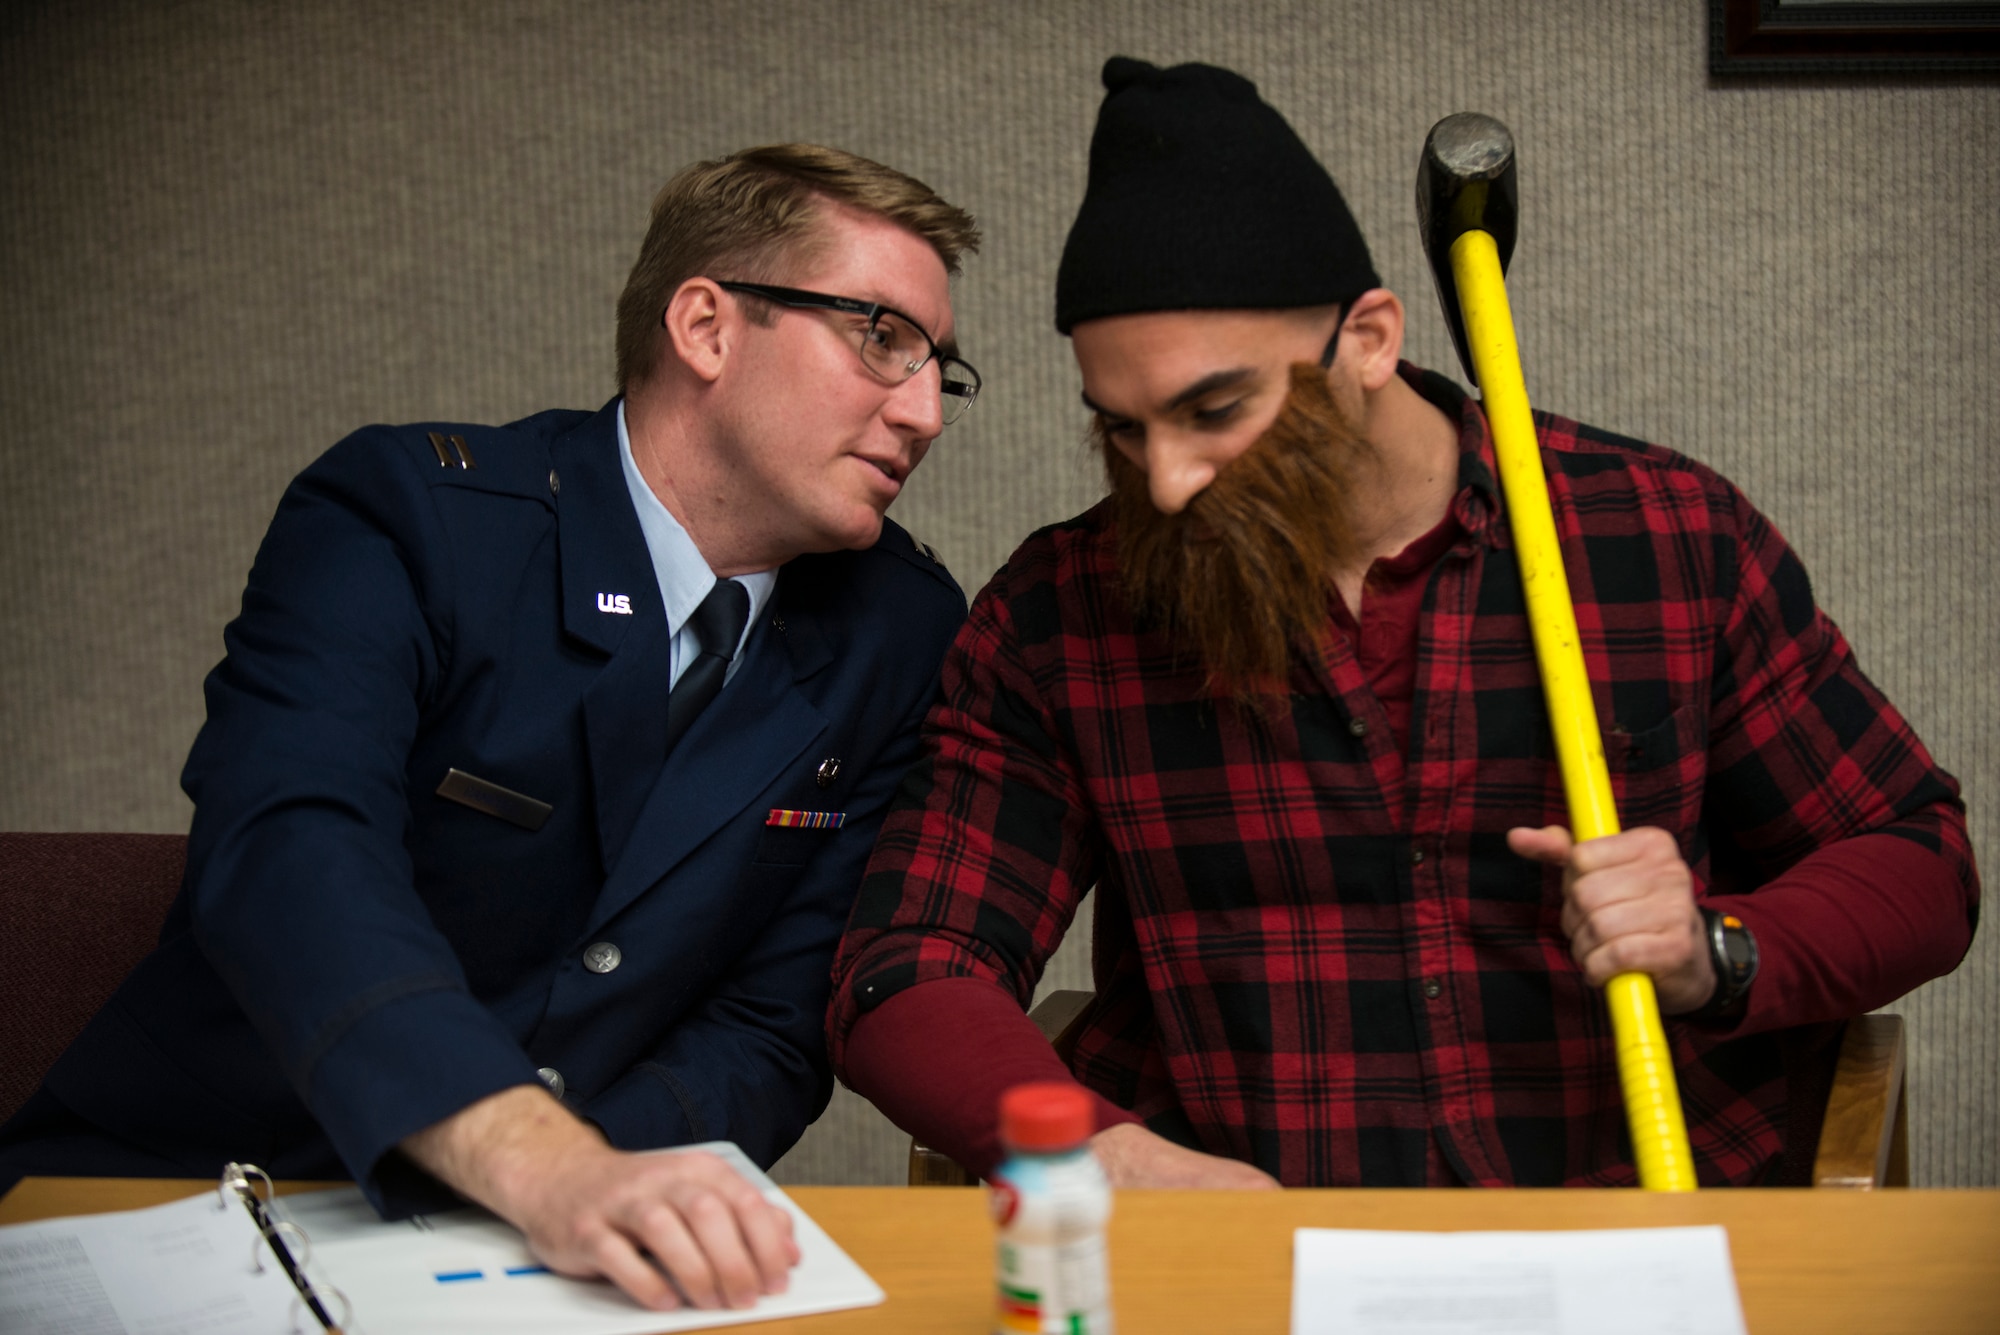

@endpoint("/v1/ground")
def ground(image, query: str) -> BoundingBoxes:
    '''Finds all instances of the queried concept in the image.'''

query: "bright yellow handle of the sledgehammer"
[1452,230,1694,1191]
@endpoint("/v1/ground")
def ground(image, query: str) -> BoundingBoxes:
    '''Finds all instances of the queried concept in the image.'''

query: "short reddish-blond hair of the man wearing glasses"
[618,144,980,390]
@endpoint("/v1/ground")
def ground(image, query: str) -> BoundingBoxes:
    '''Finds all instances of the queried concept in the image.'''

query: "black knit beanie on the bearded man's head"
[1056,56,1382,334]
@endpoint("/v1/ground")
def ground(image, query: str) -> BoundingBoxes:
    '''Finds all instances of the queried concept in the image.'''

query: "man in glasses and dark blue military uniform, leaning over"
[0,146,978,1307]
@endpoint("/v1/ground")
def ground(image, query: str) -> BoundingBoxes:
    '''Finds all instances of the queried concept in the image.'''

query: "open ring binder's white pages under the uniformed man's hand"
[0,1141,882,1335]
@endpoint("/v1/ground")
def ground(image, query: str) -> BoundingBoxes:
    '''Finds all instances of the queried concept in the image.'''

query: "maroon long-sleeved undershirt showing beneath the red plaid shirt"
[846,516,1972,1175]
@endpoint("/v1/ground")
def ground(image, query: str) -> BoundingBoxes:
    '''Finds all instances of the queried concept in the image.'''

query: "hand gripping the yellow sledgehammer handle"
[1506,825,1716,1015]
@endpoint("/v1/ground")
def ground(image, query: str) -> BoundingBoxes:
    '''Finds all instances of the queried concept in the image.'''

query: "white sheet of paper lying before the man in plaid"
[1292,1225,1746,1335]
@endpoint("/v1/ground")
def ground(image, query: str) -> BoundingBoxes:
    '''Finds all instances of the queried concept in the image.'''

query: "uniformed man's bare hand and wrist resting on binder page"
[402,1085,798,1311]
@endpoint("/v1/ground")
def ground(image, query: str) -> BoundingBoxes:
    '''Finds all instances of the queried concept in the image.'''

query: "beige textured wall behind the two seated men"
[0,0,2000,1185]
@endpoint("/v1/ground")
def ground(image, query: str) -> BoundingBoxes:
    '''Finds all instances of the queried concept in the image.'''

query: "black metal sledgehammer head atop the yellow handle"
[1416,112,1520,384]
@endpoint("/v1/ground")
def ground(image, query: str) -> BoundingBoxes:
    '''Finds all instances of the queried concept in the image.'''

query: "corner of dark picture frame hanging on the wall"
[1708,0,2000,78]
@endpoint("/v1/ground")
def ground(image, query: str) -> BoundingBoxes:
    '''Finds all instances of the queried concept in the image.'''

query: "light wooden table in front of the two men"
[0,1177,2000,1335]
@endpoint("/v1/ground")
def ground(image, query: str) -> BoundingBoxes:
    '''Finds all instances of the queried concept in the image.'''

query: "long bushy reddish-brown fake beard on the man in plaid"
[1092,364,1372,701]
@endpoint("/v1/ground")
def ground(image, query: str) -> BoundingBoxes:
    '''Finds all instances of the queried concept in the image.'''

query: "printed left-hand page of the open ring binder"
[0,1191,294,1335]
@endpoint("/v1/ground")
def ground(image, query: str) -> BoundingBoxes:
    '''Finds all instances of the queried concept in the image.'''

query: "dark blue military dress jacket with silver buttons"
[35,393,966,1215]
